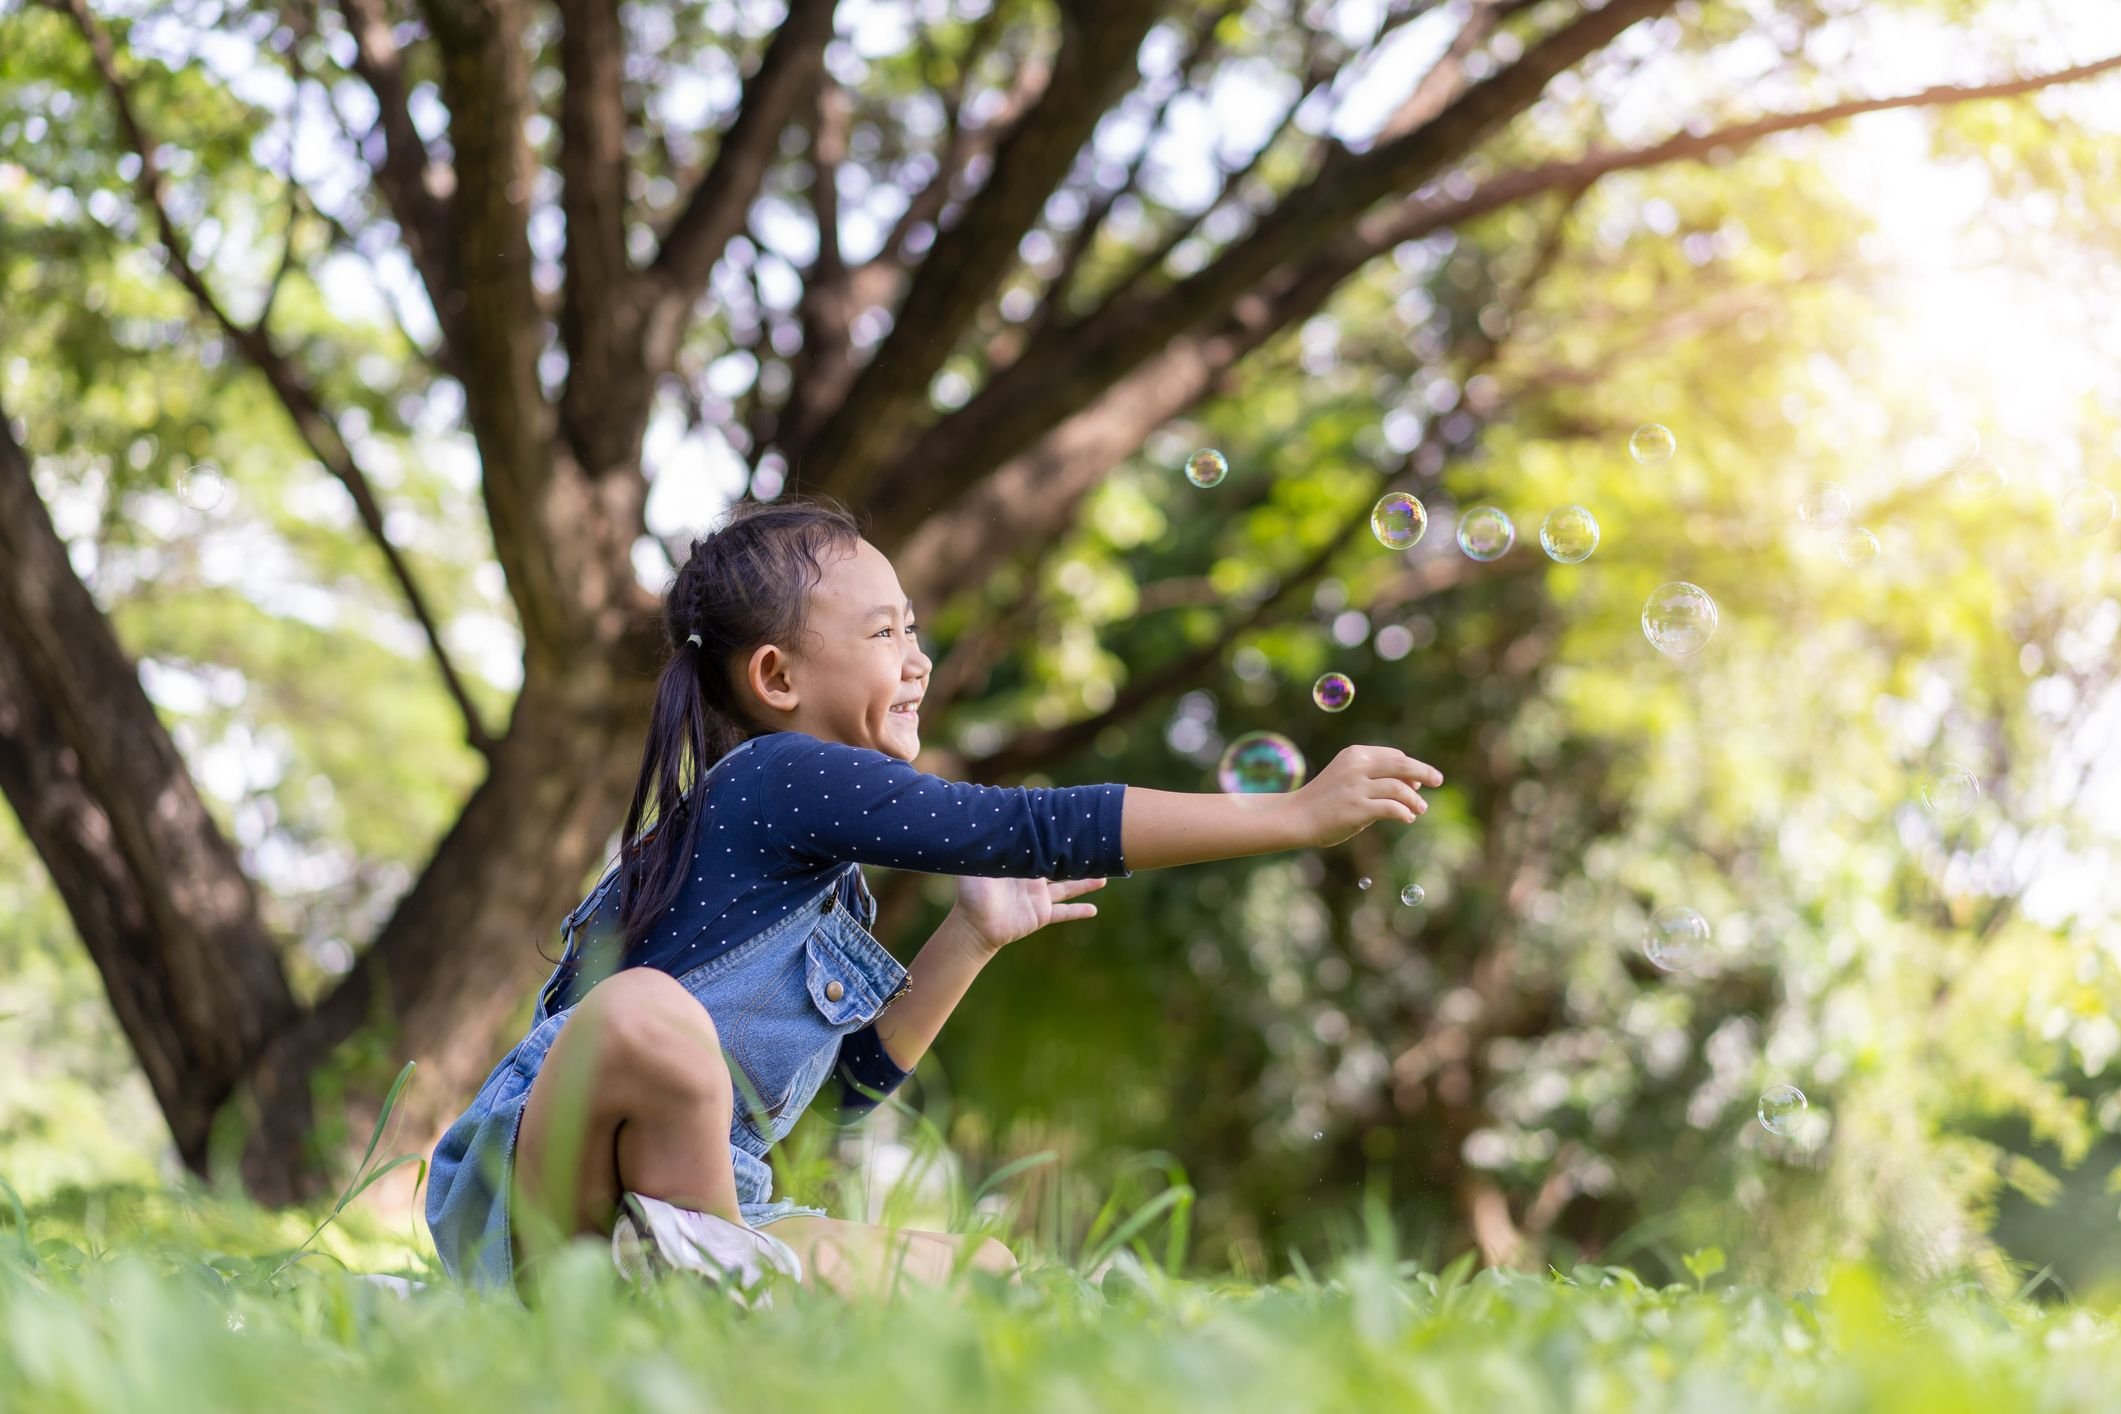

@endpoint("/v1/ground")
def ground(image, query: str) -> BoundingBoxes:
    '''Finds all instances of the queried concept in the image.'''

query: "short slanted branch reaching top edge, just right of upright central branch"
[643,0,834,373]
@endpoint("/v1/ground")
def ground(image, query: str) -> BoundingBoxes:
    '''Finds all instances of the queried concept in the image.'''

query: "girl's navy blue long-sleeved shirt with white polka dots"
[558,731,1126,1092]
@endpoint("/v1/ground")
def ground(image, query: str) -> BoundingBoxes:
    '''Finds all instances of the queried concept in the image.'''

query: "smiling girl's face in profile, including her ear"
[740,541,933,761]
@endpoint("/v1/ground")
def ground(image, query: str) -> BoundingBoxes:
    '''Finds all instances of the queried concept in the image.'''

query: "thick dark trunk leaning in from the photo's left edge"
[0,402,295,1172]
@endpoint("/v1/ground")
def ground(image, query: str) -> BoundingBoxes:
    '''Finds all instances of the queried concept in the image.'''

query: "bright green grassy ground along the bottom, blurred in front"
[0,1191,2121,1414]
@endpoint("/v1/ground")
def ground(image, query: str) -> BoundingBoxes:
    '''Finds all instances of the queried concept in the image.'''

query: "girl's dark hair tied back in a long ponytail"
[619,498,861,958]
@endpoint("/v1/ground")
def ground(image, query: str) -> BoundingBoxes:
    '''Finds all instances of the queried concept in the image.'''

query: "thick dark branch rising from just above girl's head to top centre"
[806,0,1156,500]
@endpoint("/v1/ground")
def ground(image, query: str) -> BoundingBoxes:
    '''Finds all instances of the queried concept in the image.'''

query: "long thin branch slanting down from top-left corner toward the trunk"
[66,0,494,755]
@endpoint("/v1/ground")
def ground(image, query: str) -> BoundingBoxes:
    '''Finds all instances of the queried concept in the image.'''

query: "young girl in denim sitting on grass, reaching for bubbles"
[426,500,1442,1293]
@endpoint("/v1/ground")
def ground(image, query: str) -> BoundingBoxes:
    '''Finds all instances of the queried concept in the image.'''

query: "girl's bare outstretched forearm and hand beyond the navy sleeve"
[1120,746,1444,869]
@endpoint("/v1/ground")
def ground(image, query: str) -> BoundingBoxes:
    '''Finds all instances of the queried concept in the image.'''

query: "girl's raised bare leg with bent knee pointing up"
[509,967,742,1268]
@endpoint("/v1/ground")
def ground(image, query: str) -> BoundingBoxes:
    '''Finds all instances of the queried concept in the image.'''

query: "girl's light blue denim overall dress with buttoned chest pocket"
[426,805,908,1291]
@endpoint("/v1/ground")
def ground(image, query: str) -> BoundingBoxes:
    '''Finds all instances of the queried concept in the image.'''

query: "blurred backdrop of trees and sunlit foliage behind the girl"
[0,0,2121,1280]
